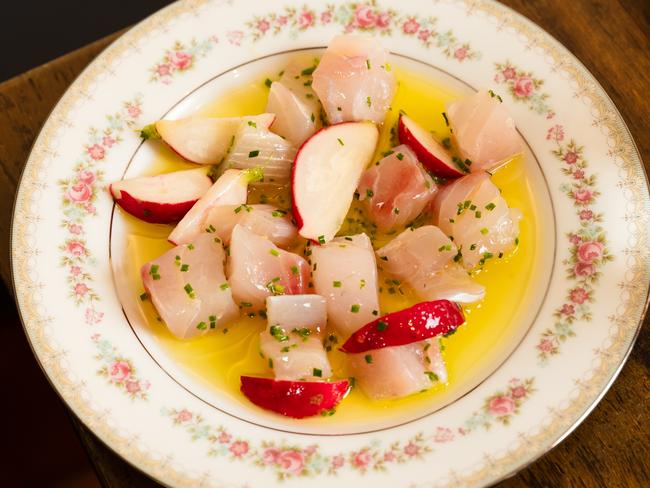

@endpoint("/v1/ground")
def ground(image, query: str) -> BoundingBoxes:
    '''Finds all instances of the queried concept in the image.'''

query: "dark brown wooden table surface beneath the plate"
[0,0,650,487]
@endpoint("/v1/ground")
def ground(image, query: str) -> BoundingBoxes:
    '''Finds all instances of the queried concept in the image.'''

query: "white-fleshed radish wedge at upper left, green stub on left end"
[140,114,275,164]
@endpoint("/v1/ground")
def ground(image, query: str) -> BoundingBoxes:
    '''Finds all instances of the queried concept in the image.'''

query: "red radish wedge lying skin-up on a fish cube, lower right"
[341,300,465,353]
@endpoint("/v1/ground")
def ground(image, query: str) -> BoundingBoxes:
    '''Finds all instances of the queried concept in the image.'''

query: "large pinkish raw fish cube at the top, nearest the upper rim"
[312,35,397,124]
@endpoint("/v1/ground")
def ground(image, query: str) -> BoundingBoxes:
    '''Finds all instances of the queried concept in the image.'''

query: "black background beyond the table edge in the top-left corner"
[0,0,172,82]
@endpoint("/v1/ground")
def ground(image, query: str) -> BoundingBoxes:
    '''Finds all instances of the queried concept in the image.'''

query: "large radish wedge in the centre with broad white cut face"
[291,122,379,244]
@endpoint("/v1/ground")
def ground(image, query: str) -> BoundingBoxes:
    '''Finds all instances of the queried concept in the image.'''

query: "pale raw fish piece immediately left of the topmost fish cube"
[266,55,323,147]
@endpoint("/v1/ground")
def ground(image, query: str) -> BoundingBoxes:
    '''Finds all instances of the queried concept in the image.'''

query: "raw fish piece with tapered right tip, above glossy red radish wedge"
[377,225,485,303]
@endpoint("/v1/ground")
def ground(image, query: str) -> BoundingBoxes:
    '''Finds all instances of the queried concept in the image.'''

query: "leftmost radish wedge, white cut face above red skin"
[109,168,212,224]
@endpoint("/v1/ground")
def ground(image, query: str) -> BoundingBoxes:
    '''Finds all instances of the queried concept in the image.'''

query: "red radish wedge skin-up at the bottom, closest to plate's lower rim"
[241,376,350,419]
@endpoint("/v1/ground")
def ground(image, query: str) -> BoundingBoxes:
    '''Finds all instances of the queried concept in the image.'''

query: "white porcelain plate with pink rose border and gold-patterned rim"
[12,0,650,487]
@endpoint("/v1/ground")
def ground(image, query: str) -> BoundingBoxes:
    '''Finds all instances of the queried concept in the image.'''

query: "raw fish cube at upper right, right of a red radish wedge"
[447,90,523,172]
